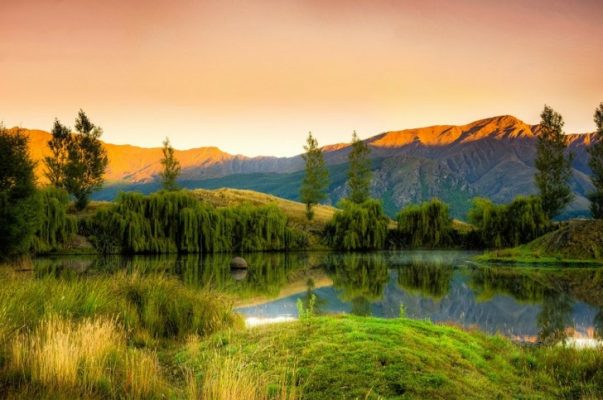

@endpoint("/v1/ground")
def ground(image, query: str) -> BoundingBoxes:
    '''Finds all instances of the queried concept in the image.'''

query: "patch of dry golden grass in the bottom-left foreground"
[6,316,164,399]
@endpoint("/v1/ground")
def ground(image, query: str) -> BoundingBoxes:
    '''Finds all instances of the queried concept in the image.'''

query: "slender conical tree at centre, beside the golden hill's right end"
[300,132,329,221]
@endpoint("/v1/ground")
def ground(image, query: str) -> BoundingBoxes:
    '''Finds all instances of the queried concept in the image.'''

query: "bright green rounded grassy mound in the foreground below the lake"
[178,316,603,399]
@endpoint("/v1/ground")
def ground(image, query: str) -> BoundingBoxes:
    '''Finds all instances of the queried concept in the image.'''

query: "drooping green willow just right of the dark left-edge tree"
[33,187,77,253]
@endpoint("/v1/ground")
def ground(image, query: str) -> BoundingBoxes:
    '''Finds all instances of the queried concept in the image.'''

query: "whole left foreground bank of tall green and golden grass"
[0,268,241,399]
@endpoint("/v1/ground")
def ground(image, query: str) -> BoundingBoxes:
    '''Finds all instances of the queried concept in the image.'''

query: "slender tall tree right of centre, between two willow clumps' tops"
[348,131,371,204]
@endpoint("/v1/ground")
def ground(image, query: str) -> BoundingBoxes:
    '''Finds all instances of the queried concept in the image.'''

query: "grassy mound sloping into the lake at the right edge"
[479,220,603,263]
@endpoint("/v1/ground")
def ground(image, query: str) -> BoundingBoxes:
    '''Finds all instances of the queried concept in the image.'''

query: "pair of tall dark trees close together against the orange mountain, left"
[44,110,109,210]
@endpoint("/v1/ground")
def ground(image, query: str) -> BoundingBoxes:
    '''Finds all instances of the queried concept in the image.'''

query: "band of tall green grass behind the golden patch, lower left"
[0,269,239,339]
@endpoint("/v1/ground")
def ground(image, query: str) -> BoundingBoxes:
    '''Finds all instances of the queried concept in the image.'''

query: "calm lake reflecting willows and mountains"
[33,251,603,342]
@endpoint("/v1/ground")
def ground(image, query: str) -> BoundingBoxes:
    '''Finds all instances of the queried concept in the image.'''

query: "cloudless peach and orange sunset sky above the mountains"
[0,0,603,156]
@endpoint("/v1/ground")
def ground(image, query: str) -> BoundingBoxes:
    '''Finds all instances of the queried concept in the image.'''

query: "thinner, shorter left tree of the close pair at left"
[44,119,72,188]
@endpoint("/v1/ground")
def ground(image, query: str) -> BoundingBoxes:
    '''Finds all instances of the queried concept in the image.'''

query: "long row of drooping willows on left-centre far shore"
[85,191,306,253]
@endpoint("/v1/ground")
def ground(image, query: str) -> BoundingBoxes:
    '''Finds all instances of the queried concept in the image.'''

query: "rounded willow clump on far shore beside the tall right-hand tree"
[469,196,549,248]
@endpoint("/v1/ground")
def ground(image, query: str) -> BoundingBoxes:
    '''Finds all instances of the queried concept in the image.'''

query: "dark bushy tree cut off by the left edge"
[0,125,40,257]
